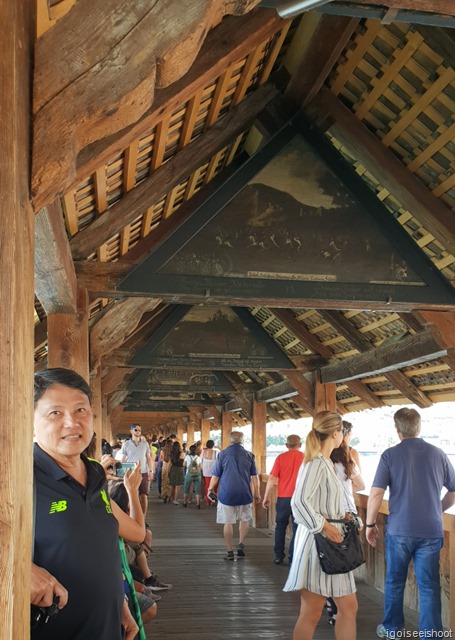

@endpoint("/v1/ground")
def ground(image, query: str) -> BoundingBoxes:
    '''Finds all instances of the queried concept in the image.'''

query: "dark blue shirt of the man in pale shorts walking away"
[212,443,258,507]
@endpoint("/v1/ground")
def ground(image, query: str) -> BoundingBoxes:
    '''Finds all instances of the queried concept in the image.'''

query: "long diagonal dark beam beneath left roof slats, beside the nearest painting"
[71,81,276,258]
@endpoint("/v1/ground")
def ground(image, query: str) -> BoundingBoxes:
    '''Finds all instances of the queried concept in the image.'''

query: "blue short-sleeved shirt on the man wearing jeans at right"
[373,438,455,538]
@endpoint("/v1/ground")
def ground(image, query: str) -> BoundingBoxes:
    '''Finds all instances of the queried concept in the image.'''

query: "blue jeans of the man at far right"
[382,532,444,631]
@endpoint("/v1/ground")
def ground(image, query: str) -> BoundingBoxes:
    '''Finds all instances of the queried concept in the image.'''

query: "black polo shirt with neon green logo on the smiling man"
[31,444,124,640]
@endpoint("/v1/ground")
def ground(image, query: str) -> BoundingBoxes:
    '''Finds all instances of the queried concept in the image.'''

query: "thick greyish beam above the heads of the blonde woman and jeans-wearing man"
[320,331,447,383]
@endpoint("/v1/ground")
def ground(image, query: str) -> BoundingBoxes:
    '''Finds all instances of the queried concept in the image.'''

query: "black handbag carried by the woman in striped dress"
[314,520,365,575]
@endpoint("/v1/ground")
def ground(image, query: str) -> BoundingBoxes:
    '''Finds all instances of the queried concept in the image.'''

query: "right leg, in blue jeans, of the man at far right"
[413,538,444,631]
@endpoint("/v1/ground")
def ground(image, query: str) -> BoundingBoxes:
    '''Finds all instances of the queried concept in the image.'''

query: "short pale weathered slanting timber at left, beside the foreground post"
[35,201,77,314]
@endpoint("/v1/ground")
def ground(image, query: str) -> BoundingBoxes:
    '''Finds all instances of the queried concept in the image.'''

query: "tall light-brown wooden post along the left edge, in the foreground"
[0,0,36,638]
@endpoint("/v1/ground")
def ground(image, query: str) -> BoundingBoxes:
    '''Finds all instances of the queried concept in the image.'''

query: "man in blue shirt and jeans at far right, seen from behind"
[366,408,455,638]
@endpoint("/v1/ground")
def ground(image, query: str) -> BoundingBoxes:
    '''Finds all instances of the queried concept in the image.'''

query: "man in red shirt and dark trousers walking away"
[262,435,303,564]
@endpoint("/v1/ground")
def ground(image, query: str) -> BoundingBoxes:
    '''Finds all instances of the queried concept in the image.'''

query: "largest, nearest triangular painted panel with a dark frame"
[119,127,455,306]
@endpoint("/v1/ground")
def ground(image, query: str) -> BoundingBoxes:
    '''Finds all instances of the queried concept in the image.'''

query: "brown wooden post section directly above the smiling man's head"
[47,289,89,381]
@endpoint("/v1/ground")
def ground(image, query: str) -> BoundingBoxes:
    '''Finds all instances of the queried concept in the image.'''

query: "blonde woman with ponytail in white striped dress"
[284,411,357,640]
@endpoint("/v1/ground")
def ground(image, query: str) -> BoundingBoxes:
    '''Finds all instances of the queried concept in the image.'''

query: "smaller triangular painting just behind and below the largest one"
[130,306,294,371]
